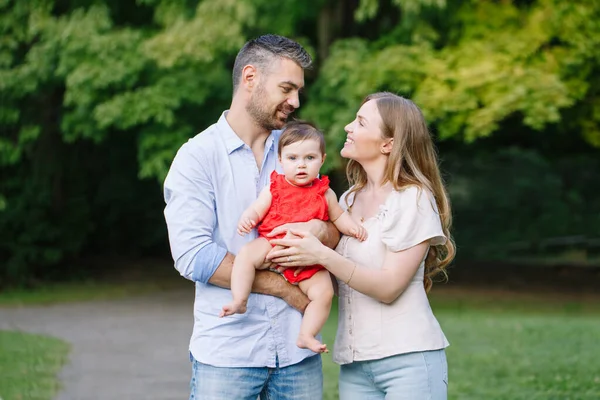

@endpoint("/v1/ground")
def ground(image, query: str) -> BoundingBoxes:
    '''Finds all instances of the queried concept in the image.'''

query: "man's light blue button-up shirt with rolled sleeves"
[164,111,315,368]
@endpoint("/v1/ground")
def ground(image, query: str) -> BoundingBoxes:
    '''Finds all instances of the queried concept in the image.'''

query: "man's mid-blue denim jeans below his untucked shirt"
[190,355,323,400]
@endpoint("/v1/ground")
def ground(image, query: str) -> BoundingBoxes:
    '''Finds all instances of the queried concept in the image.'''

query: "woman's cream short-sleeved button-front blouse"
[333,186,449,364]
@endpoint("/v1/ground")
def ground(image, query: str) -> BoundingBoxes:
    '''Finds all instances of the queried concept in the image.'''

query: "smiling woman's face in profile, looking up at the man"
[340,100,385,163]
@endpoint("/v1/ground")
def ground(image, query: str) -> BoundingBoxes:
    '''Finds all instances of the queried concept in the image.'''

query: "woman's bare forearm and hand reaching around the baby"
[269,231,429,304]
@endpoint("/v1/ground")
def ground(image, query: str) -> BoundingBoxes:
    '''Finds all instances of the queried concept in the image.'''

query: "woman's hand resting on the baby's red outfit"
[267,229,326,272]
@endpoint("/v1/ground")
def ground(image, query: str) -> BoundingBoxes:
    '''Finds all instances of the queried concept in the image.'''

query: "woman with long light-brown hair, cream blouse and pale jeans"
[269,93,454,400]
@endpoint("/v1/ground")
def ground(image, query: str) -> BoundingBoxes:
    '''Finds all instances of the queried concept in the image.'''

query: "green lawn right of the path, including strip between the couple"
[323,292,600,400]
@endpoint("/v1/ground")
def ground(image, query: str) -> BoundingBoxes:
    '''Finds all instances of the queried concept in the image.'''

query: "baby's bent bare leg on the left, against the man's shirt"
[219,238,272,317]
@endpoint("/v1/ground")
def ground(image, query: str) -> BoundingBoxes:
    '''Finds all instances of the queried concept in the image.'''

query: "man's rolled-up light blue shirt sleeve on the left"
[164,144,227,283]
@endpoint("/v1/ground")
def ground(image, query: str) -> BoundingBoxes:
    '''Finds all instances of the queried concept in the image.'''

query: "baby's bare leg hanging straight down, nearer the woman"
[297,270,333,353]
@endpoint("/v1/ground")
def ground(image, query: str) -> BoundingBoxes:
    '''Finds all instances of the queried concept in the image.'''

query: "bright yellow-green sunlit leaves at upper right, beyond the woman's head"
[415,2,600,141]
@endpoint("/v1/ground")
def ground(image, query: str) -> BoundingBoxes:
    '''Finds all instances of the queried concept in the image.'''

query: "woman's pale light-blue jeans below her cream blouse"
[340,349,448,400]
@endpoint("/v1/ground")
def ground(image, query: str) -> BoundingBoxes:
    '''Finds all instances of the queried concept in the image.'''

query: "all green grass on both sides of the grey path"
[0,284,600,400]
